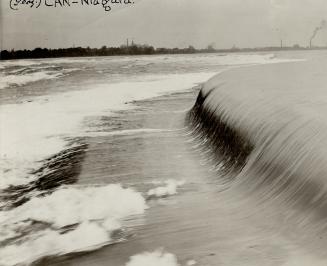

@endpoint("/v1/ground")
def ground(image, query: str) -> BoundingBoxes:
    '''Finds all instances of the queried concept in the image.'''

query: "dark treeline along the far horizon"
[0,44,327,60]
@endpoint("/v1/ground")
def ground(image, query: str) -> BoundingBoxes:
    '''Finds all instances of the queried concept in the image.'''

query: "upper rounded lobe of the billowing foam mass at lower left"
[0,184,146,231]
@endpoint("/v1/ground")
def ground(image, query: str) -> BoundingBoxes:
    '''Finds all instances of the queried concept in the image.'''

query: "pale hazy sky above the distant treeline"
[0,0,327,50]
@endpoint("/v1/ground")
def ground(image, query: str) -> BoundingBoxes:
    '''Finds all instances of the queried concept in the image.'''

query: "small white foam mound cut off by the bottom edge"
[126,250,180,266]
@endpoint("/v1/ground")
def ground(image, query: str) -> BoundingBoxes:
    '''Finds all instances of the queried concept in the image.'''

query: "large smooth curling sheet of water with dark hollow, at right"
[186,60,327,228]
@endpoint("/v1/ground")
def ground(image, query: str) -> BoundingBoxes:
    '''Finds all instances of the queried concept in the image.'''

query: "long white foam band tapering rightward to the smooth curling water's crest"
[0,73,214,188]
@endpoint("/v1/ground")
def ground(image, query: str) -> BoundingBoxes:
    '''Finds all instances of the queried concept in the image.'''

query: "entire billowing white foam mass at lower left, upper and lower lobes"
[0,184,147,265]
